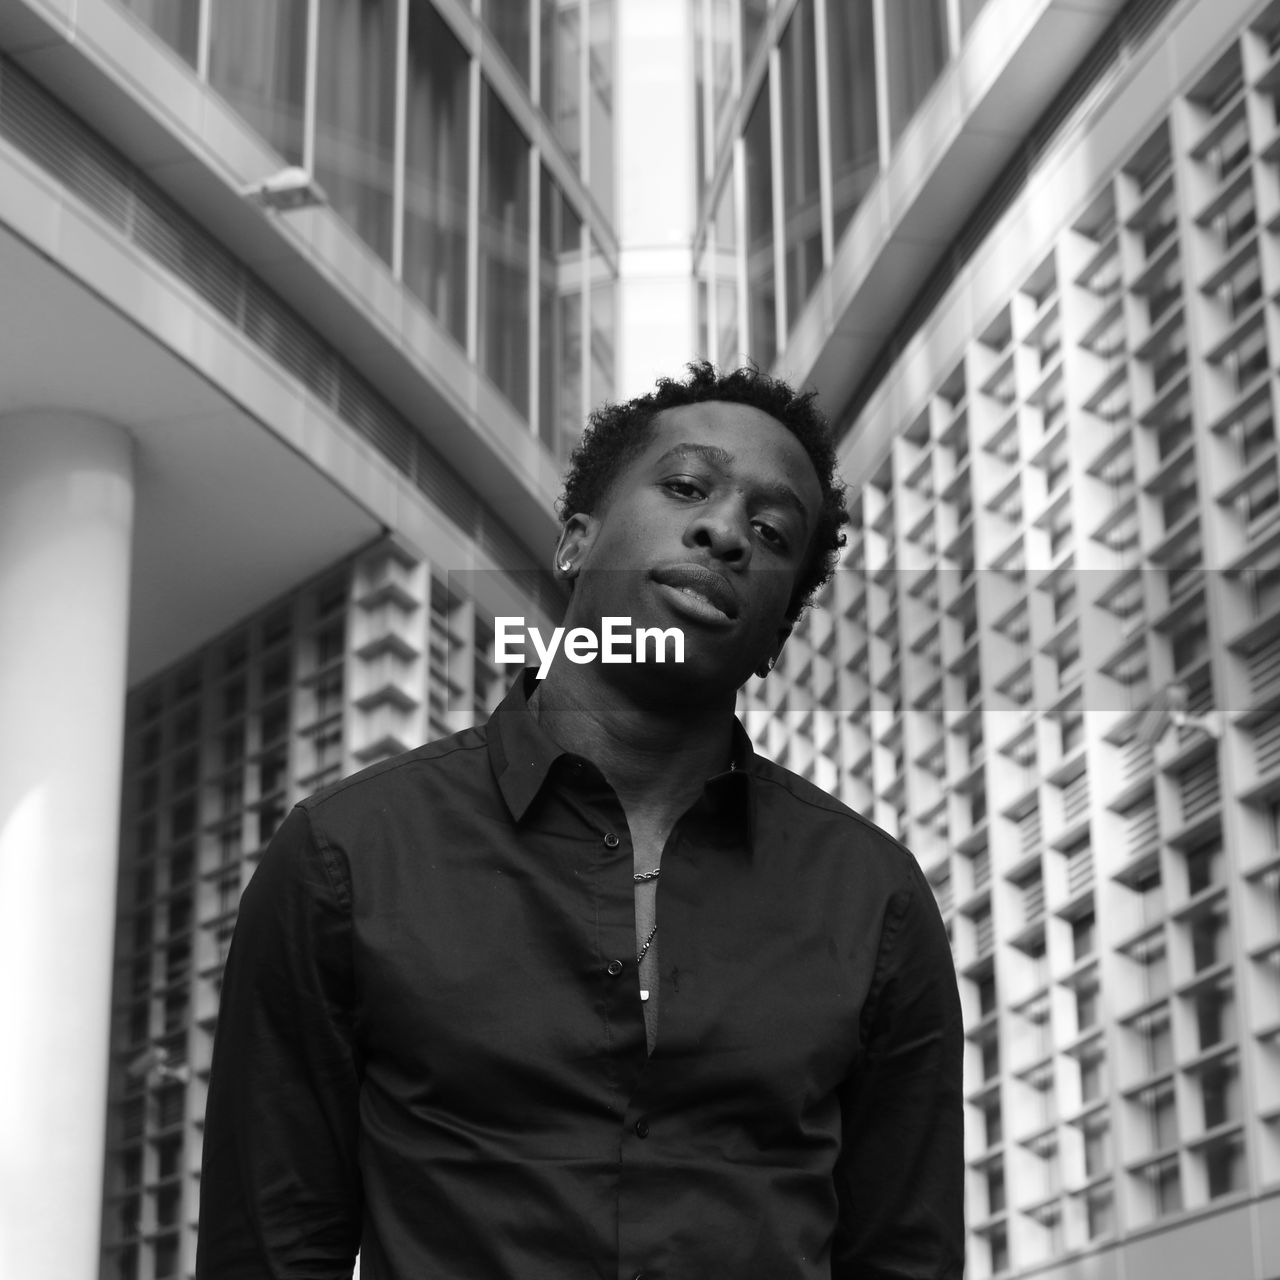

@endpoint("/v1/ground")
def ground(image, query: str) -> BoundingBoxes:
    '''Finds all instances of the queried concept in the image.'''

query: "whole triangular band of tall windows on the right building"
[690,0,962,366]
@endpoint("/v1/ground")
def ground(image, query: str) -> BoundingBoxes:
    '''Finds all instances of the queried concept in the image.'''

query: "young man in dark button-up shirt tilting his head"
[197,365,963,1280]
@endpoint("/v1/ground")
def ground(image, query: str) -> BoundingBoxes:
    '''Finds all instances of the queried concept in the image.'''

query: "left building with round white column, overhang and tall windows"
[0,0,629,1280]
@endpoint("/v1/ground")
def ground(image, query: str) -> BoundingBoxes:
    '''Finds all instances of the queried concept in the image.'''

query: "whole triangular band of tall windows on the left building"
[122,0,618,457]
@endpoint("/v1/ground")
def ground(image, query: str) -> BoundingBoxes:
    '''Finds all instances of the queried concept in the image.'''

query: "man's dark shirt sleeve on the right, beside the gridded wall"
[832,860,964,1280]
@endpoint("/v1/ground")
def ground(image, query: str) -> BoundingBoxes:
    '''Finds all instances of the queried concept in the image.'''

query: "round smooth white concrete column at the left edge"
[0,411,133,1280]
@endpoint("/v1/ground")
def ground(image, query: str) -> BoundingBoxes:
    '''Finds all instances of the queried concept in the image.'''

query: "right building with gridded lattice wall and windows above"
[695,0,1280,1280]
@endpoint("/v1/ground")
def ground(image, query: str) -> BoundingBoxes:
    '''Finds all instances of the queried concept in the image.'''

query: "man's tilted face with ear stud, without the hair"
[557,401,822,694]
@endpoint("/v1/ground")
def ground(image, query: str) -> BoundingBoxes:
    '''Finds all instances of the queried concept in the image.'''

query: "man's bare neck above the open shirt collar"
[530,664,733,826]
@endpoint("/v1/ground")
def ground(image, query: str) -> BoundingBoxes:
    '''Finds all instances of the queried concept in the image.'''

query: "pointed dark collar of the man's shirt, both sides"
[486,667,758,844]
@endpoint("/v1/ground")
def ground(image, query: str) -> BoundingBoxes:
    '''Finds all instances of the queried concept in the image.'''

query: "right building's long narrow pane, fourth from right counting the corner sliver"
[778,0,819,328]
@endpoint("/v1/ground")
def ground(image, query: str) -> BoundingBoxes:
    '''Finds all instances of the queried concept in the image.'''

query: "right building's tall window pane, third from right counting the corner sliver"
[827,0,879,238]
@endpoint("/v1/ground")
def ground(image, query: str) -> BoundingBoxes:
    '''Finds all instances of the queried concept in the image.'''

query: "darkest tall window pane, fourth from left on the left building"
[403,4,471,344]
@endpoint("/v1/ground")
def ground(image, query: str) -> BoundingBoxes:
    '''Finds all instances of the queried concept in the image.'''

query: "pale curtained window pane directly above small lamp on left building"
[209,0,307,164]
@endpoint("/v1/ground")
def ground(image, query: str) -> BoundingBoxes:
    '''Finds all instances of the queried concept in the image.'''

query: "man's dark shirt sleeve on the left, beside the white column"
[196,808,362,1280]
